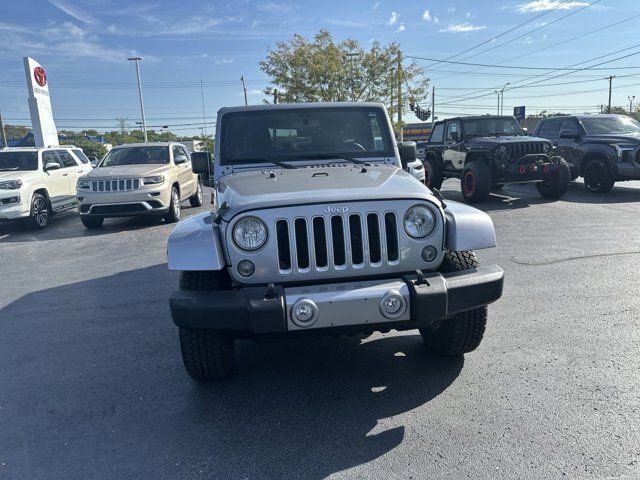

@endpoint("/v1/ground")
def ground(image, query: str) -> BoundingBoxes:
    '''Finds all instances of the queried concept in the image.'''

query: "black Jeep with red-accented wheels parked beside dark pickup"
[423,115,571,202]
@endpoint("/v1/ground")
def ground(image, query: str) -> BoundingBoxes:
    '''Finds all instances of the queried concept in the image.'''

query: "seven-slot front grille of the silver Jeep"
[275,212,399,273]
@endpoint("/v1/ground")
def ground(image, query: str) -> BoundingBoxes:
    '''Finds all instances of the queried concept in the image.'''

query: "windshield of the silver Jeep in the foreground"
[220,107,394,165]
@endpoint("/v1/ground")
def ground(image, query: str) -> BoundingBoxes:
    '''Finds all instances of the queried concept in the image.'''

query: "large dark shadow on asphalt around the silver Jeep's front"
[0,264,464,479]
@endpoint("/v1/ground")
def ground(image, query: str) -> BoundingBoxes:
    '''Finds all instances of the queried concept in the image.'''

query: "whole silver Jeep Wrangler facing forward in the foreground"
[168,103,503,381]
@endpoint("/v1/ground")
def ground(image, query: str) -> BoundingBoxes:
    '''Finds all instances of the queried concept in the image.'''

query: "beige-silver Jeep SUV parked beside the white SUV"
[78,142,202,228]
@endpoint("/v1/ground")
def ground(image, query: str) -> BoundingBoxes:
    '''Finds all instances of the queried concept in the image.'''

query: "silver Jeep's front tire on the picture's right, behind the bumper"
[420,250,487,355]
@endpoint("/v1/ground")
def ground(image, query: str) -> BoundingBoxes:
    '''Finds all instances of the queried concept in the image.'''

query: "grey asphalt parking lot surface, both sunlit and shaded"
[0,181,640,480]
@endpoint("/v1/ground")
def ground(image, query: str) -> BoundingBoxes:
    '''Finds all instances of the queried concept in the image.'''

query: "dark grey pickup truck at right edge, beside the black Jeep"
[535,114,640,193]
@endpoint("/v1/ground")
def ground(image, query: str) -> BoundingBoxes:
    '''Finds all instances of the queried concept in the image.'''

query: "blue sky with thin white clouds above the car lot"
[0,0,640,134]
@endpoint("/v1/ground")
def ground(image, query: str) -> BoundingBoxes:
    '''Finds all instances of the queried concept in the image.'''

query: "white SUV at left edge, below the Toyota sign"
[0,146,92,228]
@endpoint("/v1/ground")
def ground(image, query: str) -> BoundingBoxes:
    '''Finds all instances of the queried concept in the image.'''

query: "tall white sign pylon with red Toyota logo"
[24,57,58,147]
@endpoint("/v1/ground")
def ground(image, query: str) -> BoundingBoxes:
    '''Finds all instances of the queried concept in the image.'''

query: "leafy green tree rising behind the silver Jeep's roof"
[260,30,429,123]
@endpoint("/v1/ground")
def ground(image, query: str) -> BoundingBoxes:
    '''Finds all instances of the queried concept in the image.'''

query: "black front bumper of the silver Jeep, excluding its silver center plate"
[170,265,504,336]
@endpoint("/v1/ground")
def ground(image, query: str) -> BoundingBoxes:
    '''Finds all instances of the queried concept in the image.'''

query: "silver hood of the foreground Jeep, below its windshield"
[218,166,438,219]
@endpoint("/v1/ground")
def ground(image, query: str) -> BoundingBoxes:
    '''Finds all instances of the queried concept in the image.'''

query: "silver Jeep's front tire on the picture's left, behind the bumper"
[180,271,235,382]
